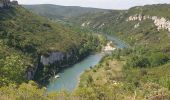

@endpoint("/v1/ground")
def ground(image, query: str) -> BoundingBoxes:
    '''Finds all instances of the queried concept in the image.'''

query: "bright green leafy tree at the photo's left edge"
[0,54,25,85]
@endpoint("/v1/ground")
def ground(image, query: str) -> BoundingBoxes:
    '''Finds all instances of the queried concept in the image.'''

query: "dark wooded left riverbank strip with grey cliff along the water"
[34,33,106,86]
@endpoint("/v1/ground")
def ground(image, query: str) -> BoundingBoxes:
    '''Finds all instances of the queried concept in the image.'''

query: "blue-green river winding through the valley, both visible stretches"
[47,35,127,92]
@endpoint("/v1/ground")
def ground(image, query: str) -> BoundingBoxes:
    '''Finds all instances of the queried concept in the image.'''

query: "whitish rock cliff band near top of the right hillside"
[126,14,170,32]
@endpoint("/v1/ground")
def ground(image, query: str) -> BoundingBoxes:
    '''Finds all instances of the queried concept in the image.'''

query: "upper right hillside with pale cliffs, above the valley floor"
[72,4,170,48]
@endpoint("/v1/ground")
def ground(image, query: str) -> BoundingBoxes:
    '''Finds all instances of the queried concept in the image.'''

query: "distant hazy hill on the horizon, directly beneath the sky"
[23,4,108,21]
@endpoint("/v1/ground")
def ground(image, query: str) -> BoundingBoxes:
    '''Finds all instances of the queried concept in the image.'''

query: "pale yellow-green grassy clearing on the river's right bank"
[79,56,124,88]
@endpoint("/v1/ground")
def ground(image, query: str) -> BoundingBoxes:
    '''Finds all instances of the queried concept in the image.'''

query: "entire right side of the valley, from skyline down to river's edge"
[68,4,170,100]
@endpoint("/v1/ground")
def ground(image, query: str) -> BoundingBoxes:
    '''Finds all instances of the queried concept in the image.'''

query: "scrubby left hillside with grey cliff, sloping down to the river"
[0,6,105,86]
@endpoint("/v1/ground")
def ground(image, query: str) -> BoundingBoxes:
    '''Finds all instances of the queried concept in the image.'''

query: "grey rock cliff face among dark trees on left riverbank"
[40,52,65,65]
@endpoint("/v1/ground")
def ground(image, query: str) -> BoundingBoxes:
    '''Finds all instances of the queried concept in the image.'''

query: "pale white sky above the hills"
[17,0,170,9]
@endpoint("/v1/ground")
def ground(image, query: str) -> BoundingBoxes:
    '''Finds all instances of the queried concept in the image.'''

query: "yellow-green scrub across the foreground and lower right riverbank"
[0,51,170,100]
